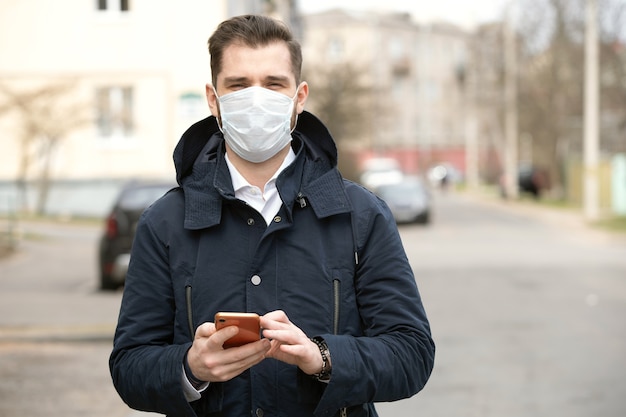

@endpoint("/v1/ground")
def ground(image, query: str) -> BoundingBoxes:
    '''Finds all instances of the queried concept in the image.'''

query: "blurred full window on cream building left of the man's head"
[96,87,134,140]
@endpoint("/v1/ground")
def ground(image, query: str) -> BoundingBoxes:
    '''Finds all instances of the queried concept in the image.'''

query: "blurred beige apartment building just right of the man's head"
[304,9,468,176]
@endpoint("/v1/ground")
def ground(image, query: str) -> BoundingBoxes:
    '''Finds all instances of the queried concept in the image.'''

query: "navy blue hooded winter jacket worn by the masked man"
[110,112,435,417]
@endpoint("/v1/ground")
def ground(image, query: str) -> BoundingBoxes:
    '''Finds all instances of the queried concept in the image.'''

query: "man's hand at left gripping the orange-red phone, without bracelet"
[187,323,271,382]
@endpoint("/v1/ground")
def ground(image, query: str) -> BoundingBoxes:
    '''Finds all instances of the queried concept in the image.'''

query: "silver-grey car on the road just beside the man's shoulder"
[376,177,432,224]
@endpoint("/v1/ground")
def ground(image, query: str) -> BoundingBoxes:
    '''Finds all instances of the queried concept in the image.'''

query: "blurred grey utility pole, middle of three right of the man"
[504,3,519,199]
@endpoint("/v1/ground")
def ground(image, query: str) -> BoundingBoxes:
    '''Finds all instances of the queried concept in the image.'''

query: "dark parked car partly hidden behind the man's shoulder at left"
[98,180,175,290]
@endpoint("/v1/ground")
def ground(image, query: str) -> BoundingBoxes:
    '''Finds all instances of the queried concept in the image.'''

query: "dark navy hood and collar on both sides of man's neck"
[174,112,351,229]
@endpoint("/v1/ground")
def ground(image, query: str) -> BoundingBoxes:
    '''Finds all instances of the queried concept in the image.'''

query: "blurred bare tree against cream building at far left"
[0,82,91,214]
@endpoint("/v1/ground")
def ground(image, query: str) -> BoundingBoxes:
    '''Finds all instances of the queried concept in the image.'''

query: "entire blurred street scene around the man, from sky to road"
[0,0,626,417]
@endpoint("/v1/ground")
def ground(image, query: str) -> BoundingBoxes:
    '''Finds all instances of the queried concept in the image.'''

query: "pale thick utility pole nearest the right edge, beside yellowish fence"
[583,0,600,221]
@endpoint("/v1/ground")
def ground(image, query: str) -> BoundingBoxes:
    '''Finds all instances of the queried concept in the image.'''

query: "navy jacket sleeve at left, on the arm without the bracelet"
[109,209,196,416]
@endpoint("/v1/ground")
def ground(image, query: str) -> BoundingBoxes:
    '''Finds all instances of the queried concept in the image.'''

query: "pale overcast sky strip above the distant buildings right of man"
[299,0,507,27]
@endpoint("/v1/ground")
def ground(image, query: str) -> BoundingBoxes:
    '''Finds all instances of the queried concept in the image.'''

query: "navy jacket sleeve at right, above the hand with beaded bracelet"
[315,189,435,416]
